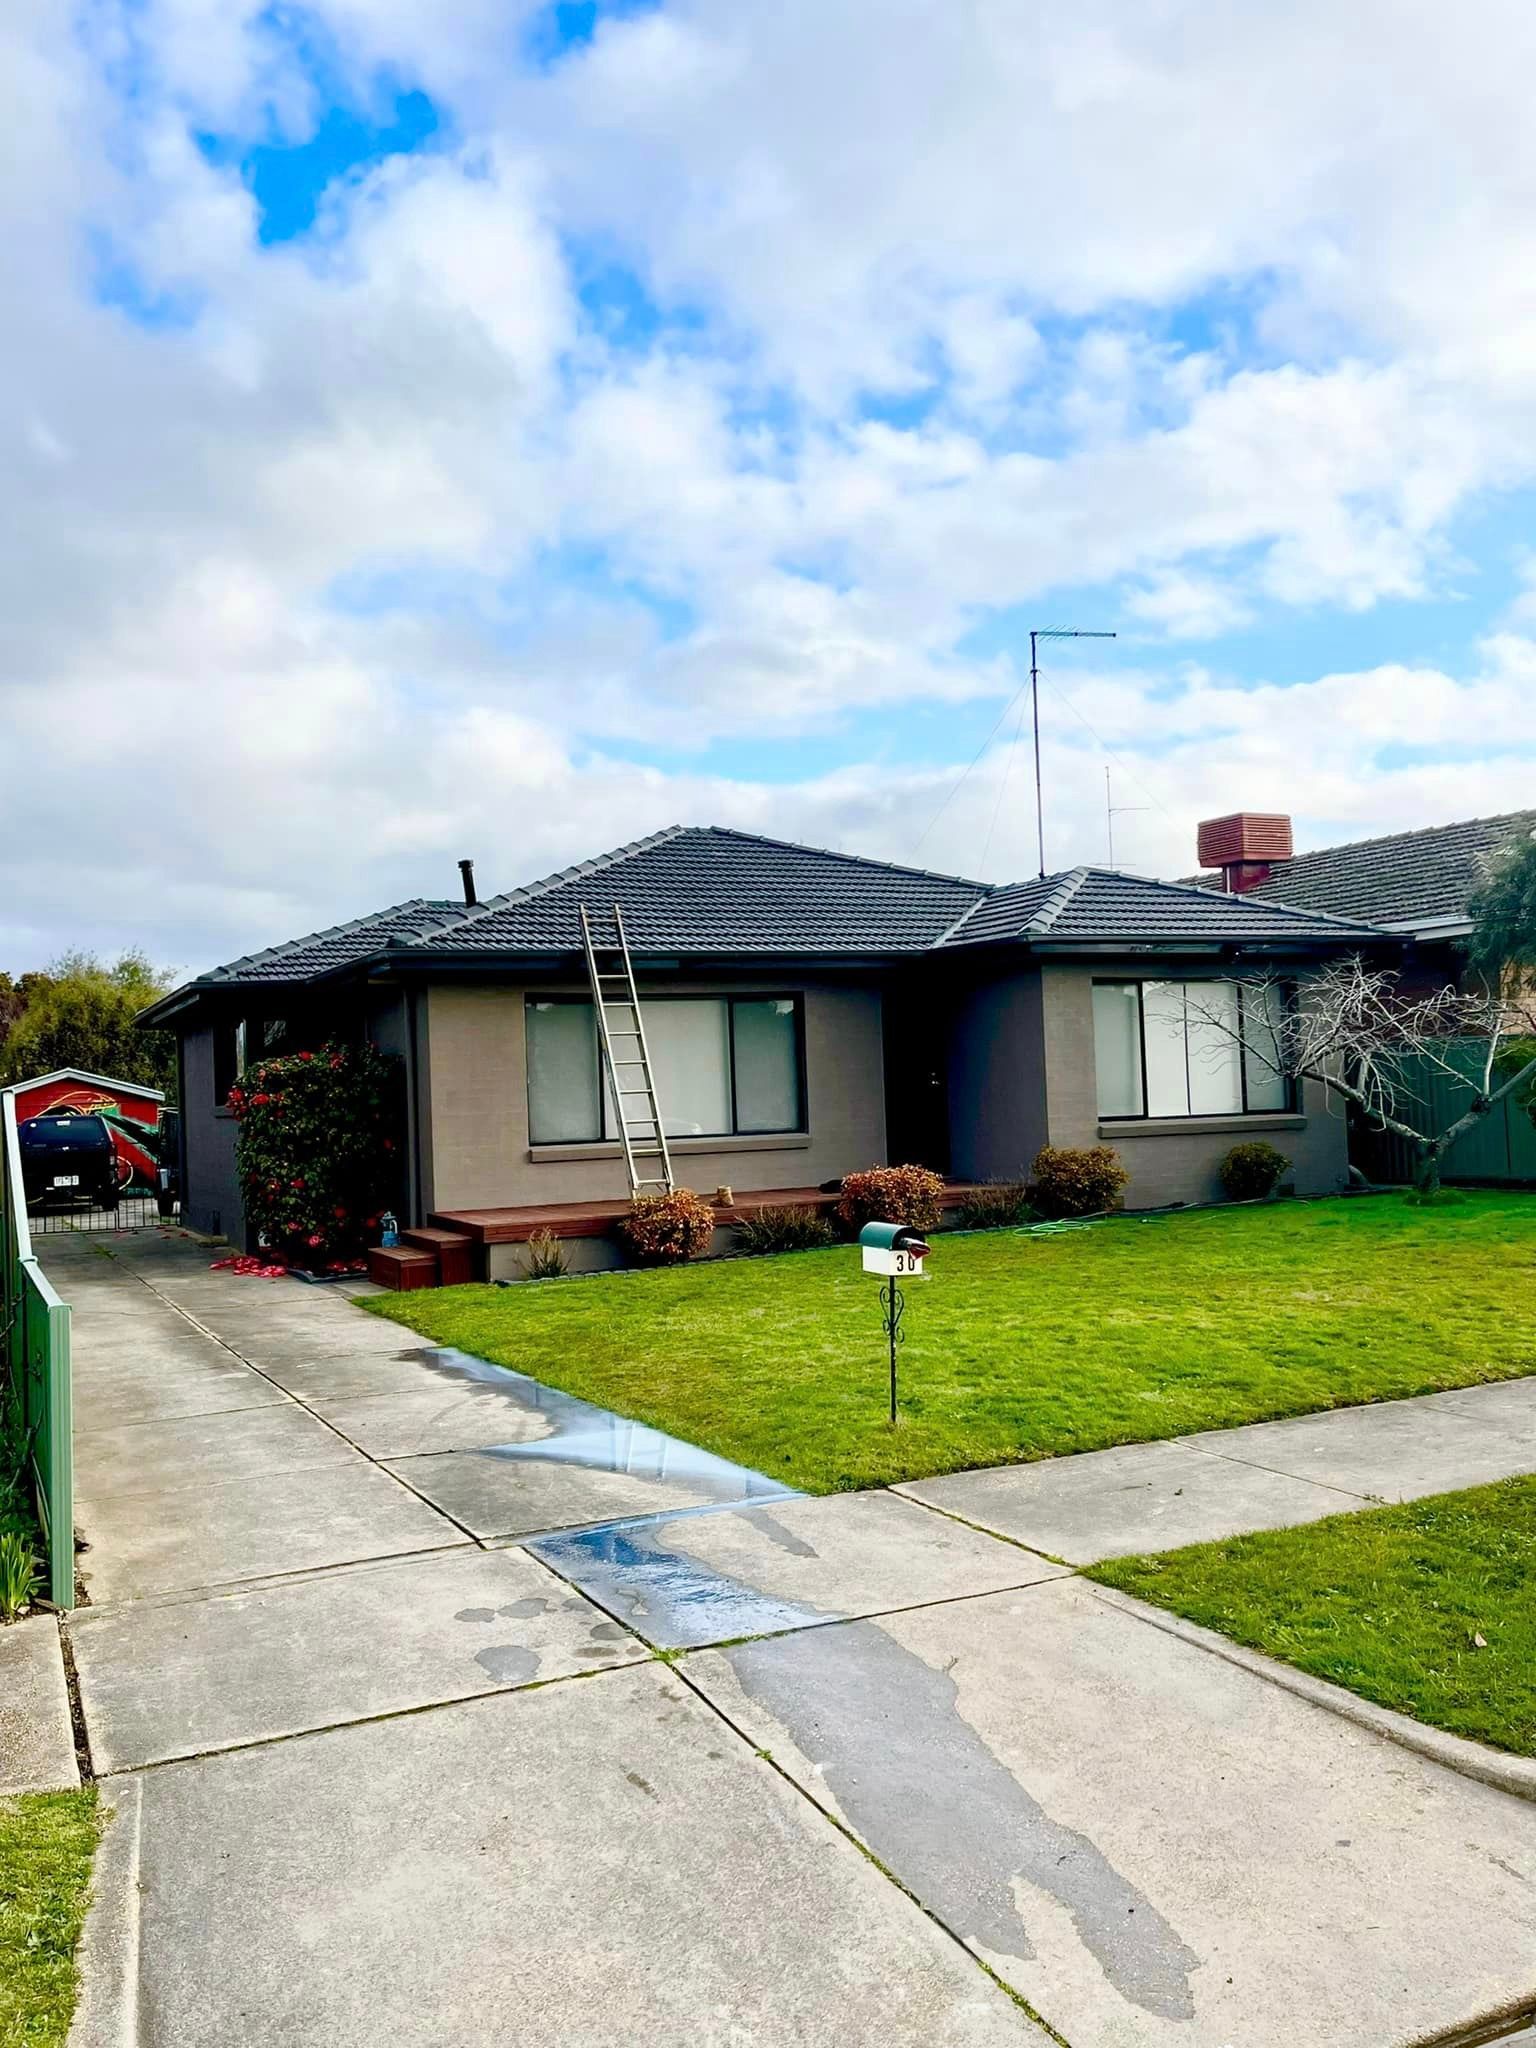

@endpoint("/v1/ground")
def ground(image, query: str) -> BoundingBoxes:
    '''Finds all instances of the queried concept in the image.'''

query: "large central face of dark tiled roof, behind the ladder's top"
[426,825,987,956]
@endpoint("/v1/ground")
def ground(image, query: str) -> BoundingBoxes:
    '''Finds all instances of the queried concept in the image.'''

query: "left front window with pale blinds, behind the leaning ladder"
[528,995,805,1145]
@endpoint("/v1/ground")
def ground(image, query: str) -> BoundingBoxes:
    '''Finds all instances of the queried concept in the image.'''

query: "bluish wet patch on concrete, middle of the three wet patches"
[528,1509,842,1651]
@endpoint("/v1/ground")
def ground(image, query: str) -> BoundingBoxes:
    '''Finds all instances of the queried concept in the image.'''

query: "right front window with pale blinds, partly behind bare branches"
[1094,981,1292,1116]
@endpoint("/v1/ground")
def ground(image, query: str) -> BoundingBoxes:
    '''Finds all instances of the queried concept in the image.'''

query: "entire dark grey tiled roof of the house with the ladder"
[143,825,1382,1024]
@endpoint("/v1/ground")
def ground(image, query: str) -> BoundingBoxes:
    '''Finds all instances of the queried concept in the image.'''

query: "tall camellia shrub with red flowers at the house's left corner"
[229,1044,401,1272]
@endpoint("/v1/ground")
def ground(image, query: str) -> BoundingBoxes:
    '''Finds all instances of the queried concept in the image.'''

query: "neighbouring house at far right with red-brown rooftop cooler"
[1188,811,1536,989]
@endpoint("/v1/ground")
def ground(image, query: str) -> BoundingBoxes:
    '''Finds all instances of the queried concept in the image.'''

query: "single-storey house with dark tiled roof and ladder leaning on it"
[143,825,1399,1278]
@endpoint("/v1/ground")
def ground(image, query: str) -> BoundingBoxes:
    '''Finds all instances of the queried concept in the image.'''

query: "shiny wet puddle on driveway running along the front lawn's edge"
[401,1346,797,1505]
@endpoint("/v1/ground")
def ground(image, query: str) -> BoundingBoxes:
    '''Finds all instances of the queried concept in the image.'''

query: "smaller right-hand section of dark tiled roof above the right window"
[944,868,1380,946]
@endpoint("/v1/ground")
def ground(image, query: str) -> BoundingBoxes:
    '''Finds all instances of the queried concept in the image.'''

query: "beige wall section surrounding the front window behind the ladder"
[422,977,885,1210]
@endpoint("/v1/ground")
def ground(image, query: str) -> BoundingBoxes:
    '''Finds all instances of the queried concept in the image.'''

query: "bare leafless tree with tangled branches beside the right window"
[1190,958,1536,1194]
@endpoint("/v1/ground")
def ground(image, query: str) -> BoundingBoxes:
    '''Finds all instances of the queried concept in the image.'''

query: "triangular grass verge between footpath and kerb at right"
[1087,1479,1536,1757]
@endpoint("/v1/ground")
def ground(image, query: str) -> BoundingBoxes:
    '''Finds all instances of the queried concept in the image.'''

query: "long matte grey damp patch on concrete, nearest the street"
[721,1622,1200,2019]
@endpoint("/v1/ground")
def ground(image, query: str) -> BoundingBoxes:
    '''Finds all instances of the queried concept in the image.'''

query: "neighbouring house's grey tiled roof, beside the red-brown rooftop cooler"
[1192,811,1536,926]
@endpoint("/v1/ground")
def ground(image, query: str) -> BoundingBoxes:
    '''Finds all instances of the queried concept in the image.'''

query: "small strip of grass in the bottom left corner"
[0,1792,100,2048]
